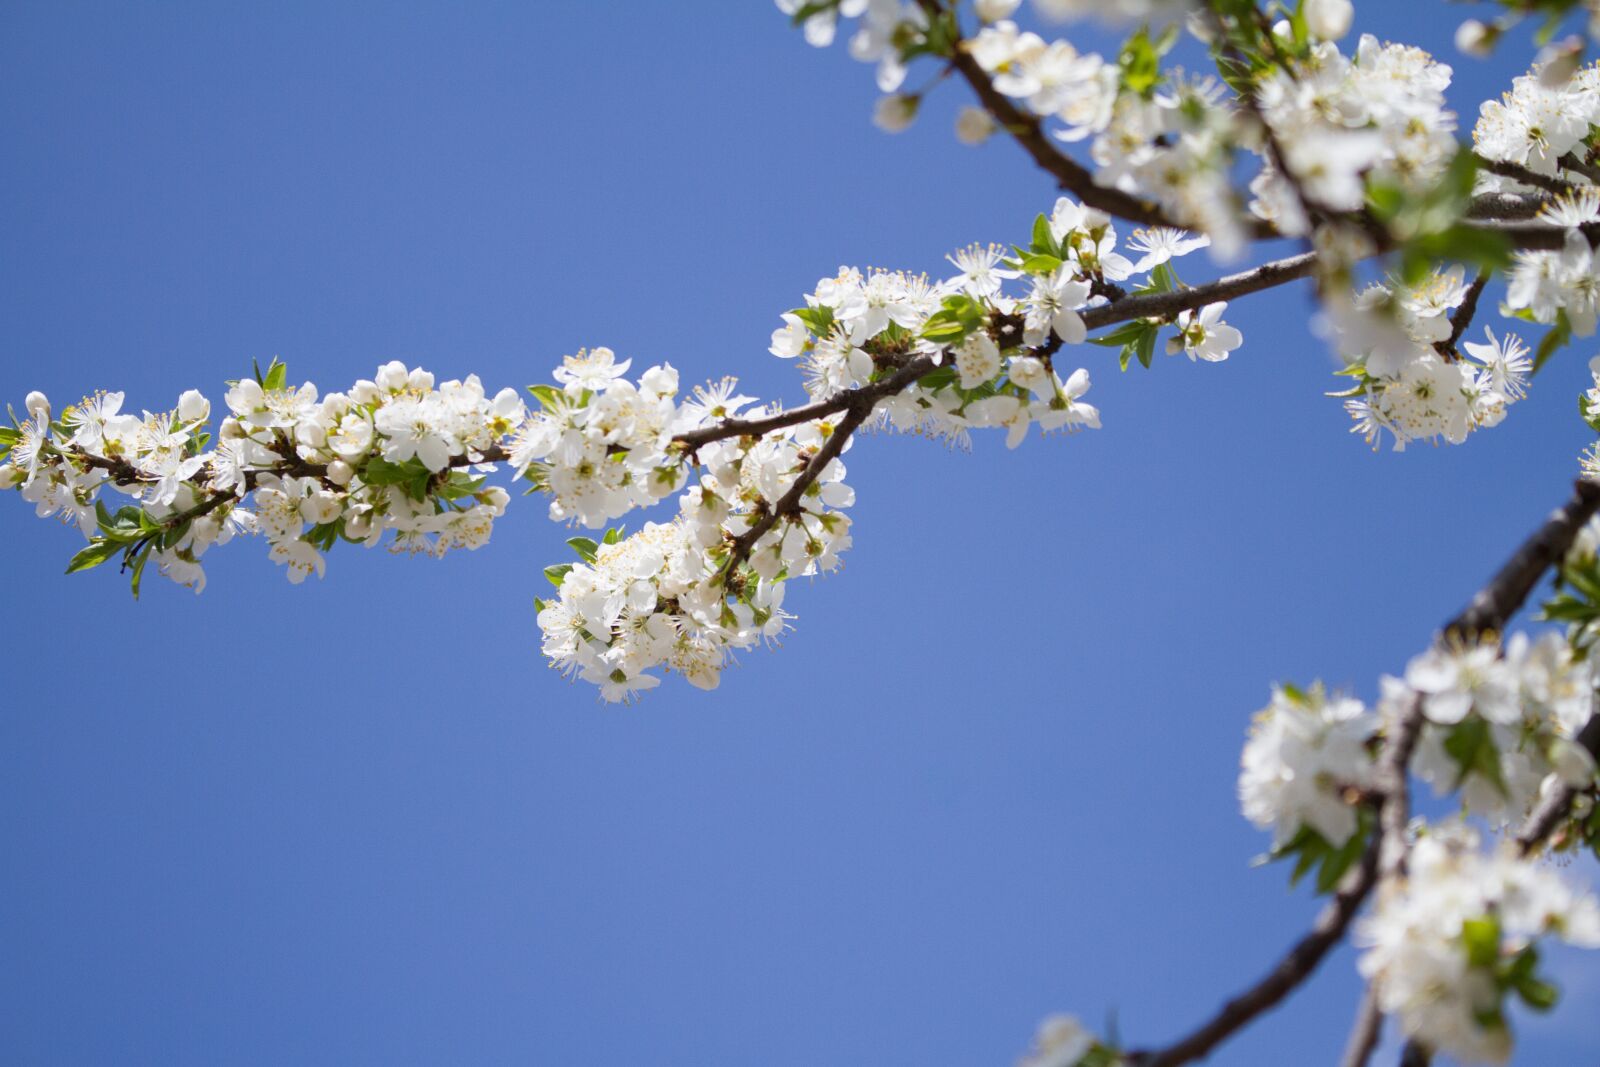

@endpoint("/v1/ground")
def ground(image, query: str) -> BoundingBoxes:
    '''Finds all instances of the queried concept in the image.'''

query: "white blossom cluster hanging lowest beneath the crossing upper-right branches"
[1328,267,1533,450]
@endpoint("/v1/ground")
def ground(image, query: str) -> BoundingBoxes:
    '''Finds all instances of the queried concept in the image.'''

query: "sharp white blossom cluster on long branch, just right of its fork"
[770,197,1243,448]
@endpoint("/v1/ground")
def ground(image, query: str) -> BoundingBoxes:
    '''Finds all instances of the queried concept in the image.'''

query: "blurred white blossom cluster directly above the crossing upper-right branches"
[1251,29,1458,234]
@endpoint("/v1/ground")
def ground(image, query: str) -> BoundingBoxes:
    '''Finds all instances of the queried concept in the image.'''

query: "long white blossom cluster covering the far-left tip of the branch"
[0,363,525,592]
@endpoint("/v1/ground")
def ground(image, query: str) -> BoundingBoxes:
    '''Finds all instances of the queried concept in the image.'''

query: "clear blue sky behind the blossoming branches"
[0,0,1600,1067]
